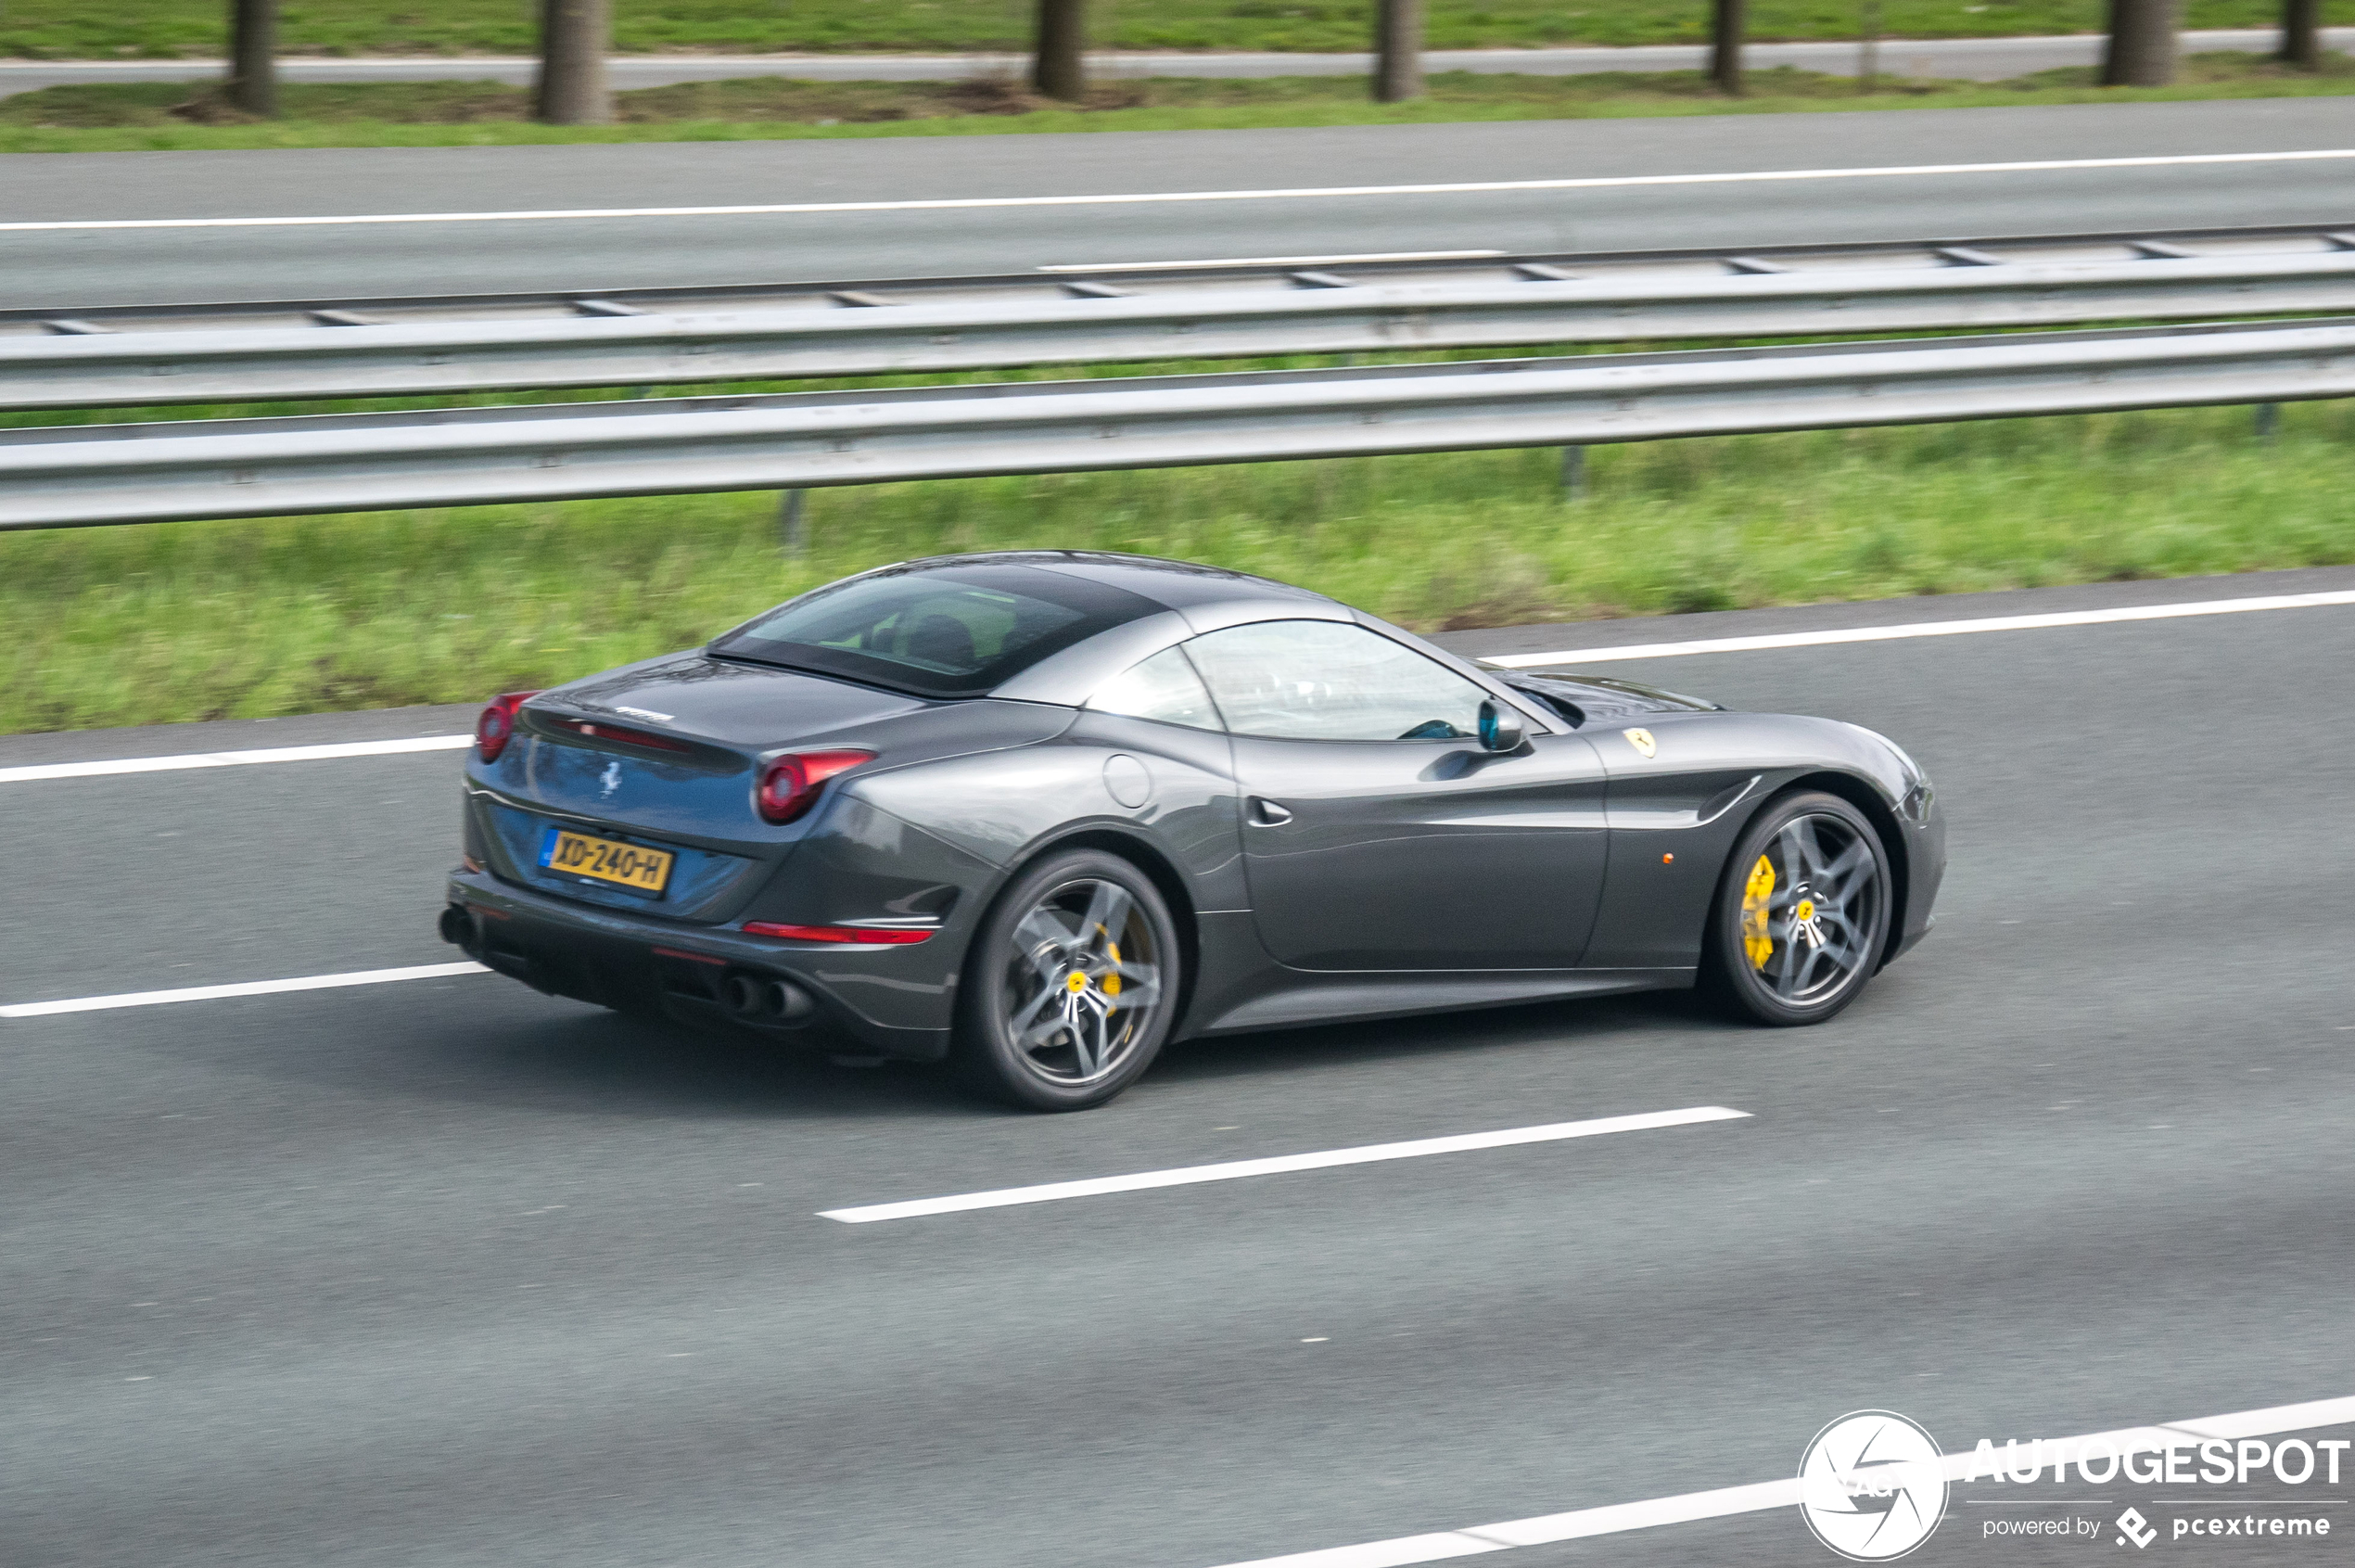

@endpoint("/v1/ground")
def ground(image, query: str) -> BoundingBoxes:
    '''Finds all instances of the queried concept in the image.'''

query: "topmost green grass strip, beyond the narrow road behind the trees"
[0,0,2355,58]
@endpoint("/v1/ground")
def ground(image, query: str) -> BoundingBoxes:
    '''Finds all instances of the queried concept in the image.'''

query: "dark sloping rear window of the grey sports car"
[711,565,1161,697]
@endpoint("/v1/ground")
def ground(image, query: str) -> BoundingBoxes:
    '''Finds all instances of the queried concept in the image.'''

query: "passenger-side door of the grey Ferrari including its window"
[1185,621,1606,970]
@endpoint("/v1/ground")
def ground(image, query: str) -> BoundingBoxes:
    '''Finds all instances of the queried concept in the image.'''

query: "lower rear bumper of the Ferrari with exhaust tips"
[443,871,963,1062]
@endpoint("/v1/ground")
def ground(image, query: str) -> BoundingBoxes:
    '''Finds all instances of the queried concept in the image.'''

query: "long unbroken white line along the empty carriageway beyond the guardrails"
[0,148,2355,233]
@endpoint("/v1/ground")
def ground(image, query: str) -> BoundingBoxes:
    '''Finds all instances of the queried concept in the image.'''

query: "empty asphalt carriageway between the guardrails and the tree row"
[0,99,2355,311]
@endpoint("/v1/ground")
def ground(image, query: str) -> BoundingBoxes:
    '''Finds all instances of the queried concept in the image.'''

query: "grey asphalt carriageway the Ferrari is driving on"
[0,569,2355,1568]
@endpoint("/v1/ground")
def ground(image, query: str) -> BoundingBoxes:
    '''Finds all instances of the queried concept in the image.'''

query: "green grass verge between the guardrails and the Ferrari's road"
[0,402,2355,733]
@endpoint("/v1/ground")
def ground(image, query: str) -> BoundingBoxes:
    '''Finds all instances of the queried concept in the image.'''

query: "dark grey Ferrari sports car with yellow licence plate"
[440,551,1945,1111]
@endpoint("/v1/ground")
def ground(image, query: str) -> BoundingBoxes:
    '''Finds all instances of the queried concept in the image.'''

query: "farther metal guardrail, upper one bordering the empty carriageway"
[13,228,2355,410]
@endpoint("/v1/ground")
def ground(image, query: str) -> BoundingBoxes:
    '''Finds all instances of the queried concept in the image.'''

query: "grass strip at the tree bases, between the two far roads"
[0,54,2355,153]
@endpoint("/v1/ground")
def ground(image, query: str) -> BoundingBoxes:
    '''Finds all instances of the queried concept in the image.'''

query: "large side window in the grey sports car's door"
[1187,621,1488,739]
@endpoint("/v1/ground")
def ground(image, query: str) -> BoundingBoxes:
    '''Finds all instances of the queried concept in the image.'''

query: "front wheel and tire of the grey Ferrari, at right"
[1700,791,1893,1026]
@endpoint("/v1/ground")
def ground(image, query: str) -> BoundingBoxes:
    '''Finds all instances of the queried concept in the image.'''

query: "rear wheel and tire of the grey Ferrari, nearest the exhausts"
[951,850,1182,1111]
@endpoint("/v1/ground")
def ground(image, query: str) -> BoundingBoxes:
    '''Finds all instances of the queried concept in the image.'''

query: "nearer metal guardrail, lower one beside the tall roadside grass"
[0,318,2355,529]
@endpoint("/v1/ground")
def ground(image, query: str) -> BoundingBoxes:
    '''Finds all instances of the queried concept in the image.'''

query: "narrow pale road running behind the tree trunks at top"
[0,28,2355,96]
